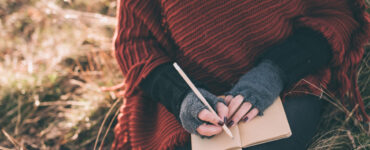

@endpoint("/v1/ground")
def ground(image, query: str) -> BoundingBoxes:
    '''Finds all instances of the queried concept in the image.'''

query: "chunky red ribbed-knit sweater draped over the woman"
[113,0,370,149]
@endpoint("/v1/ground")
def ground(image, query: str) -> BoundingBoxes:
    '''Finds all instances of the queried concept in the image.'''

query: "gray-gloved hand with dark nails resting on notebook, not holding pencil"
[225,60,283,126]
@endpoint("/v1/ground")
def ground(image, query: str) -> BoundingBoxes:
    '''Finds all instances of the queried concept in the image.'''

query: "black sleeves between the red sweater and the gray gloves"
[139,28,332,120]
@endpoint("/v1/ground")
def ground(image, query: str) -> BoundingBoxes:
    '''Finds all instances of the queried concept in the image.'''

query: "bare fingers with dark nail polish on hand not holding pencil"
[225,95,259,127]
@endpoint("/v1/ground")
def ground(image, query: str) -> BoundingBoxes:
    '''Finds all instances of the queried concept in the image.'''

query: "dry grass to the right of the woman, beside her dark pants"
[310,46,370,150]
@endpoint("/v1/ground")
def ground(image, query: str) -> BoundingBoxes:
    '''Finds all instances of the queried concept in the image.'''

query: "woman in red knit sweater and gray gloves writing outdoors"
[112,0,370,149]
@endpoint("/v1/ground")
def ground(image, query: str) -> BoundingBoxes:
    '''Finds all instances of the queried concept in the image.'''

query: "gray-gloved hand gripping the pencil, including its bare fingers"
[180,88,229,137]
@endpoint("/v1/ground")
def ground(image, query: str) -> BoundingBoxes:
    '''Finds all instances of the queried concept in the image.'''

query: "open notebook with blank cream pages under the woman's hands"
[191,98,292,150]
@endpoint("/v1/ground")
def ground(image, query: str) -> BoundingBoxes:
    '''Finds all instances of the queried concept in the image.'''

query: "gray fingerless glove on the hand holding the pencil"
[180,88,225,137]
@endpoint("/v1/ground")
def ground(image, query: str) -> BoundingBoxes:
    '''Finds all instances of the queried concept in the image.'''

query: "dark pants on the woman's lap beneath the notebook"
[175,95,323,150]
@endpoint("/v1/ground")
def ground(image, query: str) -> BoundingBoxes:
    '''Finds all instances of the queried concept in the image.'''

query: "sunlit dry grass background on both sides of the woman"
[0,0,370,150]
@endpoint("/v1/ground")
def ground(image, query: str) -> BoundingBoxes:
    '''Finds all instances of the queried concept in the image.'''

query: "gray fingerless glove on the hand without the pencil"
[225,59,283,116]
